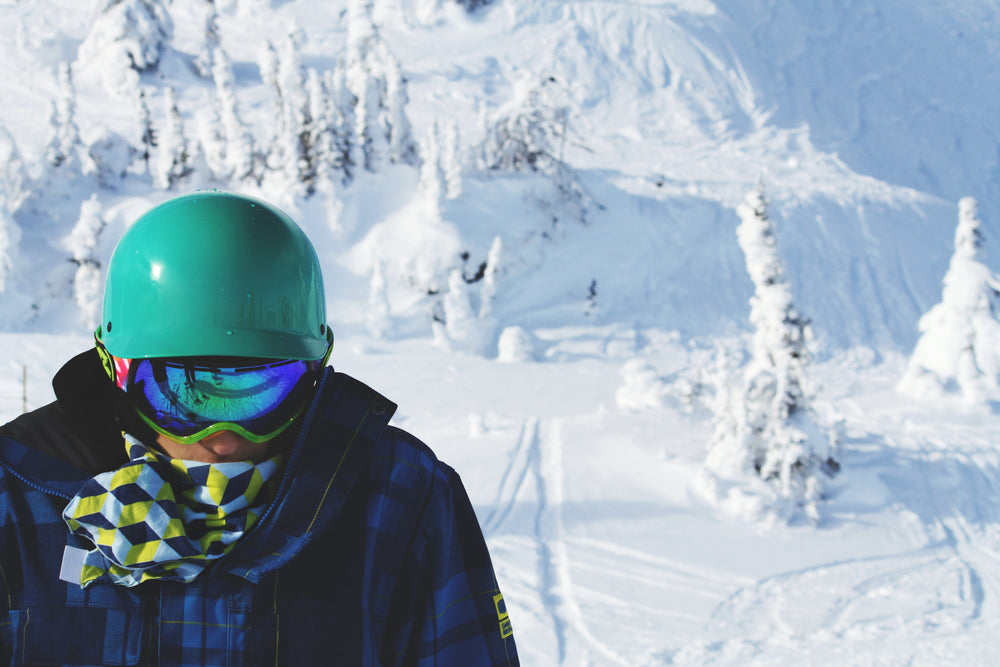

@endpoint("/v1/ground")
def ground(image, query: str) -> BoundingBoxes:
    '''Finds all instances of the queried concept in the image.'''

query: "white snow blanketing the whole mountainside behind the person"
[0,0,1000,667]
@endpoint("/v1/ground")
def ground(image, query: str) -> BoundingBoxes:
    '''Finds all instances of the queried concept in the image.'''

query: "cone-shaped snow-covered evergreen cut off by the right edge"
[898,197,1000,404]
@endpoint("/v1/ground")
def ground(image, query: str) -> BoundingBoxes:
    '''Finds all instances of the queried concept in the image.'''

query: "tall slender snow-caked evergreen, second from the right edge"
[706,186,839,518]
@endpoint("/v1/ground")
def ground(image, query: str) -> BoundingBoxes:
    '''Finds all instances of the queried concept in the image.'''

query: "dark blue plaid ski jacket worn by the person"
[0,370,519,667]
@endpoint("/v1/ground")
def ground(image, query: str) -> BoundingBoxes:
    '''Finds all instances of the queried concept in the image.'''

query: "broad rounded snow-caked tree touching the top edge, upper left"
[77,0,173,95]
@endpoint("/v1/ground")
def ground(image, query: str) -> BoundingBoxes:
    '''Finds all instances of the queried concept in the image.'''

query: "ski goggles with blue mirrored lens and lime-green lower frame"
[95,329,333,444]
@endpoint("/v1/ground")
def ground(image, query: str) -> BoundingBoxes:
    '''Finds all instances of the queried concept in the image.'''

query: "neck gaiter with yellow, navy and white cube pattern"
[63,435,281,588]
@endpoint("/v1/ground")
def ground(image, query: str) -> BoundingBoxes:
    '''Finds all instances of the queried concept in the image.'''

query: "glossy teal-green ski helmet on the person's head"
[99,191,332,359]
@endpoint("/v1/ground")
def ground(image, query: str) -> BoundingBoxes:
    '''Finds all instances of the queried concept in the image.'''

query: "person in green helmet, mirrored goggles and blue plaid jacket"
[0,191,518,667]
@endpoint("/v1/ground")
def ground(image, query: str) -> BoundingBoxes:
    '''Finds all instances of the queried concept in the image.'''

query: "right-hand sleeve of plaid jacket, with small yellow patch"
[406,471,520,667]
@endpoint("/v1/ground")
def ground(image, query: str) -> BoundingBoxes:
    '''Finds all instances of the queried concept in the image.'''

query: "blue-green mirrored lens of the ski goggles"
[127,359,322,437]
